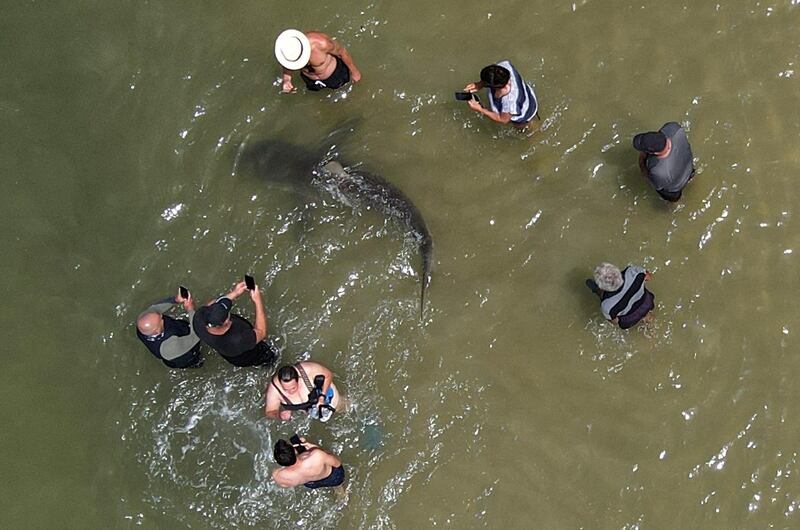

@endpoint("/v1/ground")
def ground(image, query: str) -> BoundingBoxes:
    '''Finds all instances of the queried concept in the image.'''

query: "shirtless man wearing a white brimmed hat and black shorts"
[275,29,361,93]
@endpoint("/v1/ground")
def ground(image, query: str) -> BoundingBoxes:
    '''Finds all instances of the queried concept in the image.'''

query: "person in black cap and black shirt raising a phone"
[193,282,277,366]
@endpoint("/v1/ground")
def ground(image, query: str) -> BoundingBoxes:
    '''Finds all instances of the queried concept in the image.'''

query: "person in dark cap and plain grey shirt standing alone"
[633,121,694,202]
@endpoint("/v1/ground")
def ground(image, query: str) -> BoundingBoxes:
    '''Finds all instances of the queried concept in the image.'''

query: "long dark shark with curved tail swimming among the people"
[241,141,433,318]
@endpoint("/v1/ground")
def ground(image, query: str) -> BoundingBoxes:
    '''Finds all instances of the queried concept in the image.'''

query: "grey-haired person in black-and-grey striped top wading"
[586,263,655,329]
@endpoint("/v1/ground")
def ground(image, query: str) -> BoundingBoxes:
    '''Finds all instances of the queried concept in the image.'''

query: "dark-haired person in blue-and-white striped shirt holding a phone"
[464,61,539,129]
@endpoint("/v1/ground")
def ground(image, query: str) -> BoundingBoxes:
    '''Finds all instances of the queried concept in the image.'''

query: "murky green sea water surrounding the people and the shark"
[0,0,800,529]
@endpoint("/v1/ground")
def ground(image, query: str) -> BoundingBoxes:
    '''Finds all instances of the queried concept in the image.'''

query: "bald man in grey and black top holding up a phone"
[136,290,203,368]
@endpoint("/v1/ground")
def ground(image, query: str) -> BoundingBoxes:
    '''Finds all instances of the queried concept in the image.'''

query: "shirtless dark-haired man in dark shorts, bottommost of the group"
[272,437,344,496]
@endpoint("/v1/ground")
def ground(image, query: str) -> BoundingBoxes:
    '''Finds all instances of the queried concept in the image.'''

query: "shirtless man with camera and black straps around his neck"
[264,361,340,421]
